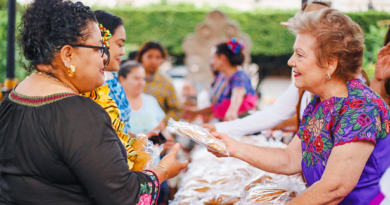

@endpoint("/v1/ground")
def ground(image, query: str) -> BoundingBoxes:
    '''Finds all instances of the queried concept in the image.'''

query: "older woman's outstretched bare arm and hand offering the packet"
[212,133,302,175]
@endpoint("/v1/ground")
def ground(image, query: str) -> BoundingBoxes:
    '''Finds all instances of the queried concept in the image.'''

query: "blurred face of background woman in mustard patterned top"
[141,48,164,73]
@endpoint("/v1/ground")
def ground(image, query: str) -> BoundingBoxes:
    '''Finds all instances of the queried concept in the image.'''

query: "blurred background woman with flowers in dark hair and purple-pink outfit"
[190,38,257,121]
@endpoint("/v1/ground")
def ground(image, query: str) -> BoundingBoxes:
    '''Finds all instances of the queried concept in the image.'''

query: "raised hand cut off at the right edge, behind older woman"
[375,43,390,80]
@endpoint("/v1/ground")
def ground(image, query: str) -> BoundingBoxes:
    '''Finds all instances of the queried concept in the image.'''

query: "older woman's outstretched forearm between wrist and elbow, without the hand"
[233,142,300,175]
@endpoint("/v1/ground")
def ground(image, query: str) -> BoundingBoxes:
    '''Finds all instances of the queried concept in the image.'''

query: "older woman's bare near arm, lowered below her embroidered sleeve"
[289,141,375,205]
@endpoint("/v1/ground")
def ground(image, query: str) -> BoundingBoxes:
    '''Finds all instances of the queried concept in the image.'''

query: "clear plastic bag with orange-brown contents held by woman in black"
[132,134,163,172]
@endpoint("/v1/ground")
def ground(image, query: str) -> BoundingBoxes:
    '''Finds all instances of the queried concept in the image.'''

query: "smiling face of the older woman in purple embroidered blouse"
[288,34,331,93]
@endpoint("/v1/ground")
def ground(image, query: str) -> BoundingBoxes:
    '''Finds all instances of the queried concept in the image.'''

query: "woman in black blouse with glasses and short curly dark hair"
[0,0,187,205]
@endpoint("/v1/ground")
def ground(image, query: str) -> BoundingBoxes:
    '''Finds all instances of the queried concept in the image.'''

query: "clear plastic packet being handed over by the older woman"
[168,118,229,156]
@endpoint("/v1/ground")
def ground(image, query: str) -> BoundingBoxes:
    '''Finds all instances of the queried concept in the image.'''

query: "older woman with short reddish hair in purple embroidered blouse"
[210,9,390,205]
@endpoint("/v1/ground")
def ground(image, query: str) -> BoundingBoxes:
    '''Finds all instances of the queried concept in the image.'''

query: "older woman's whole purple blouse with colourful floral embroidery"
[297,79,390,205]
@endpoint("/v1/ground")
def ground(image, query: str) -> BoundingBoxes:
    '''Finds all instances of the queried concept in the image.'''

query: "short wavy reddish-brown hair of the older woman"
[288,8,364,80]
